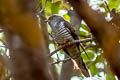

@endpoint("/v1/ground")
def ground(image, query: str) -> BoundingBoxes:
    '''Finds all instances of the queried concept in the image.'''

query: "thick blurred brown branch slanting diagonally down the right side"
[68,0,120,79]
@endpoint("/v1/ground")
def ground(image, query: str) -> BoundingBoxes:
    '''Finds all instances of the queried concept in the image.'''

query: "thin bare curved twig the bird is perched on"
[49,38,93,57]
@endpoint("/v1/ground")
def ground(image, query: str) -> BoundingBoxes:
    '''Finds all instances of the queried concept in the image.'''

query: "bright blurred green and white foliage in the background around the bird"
[0,0,120,80]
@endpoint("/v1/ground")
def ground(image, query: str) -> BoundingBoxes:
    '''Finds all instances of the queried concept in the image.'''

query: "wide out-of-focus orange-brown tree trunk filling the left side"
[0,0,51,80]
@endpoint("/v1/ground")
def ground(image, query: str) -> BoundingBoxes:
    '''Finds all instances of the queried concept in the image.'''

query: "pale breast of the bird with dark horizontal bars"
[52,22,73,44]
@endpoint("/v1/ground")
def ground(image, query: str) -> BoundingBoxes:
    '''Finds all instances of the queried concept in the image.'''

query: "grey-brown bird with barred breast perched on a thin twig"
[47,15,90,77]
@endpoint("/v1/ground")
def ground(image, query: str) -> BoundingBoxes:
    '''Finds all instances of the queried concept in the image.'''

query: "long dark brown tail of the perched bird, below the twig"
[67,45,90,77]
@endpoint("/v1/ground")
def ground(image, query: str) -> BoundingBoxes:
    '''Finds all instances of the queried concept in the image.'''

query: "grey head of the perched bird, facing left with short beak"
[48,15,64,28]
